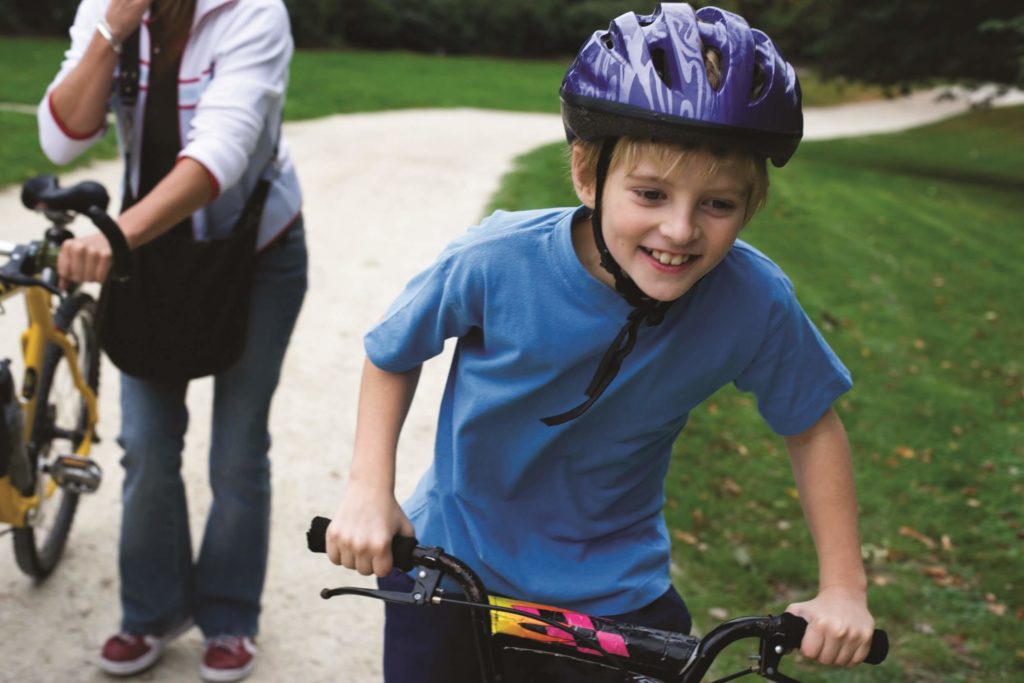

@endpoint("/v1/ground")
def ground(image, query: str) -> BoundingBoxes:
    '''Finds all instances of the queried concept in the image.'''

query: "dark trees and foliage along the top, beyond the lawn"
[0,0,1024,86]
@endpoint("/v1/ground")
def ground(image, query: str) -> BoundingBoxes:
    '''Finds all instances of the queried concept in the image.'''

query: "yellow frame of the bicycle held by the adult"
[0,248,98,527]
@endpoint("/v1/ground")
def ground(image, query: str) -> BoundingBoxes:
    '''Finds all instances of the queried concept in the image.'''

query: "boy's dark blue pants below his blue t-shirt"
[378,571,692,683]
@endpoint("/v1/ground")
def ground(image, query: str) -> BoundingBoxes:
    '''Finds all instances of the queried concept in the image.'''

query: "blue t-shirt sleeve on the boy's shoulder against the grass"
[735,276,853,436]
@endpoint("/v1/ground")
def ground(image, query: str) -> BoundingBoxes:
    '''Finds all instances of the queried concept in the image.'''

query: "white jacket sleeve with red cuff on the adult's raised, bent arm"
[36,0,109,164]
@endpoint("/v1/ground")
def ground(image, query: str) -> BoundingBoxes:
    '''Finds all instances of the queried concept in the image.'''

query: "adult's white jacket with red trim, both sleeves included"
[38,0,302,246]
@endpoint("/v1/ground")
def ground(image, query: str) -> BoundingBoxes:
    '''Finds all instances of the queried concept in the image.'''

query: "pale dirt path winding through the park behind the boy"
[0,88,1019,683]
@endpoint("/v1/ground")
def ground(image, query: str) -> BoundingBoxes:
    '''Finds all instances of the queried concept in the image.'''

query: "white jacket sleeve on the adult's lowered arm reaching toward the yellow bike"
[178,0,293,190]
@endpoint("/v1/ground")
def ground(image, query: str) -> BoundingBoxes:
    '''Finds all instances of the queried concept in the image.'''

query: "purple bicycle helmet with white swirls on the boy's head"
[560,3,804,166]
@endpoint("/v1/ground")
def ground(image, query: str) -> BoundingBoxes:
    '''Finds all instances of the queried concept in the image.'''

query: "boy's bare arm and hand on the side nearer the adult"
[327,358,420,577]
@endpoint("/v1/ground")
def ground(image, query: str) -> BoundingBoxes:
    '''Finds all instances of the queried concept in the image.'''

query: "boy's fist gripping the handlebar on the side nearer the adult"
[327,482,416,577]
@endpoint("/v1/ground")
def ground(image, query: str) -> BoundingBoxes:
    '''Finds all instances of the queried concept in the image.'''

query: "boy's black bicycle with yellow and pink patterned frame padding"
[306,517,889,683]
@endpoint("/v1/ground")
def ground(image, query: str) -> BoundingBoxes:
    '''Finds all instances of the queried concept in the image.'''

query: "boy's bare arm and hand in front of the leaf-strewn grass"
[785,409,874,667]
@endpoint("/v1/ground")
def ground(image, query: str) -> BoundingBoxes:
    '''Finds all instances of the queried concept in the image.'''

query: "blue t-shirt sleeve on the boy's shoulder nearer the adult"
[364,254,479,373]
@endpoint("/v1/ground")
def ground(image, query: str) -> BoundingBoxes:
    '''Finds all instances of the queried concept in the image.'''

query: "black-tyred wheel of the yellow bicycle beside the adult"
[13,293,99,579]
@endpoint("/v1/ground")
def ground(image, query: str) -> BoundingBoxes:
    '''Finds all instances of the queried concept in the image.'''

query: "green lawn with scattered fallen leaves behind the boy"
[485,108,1024,683]
